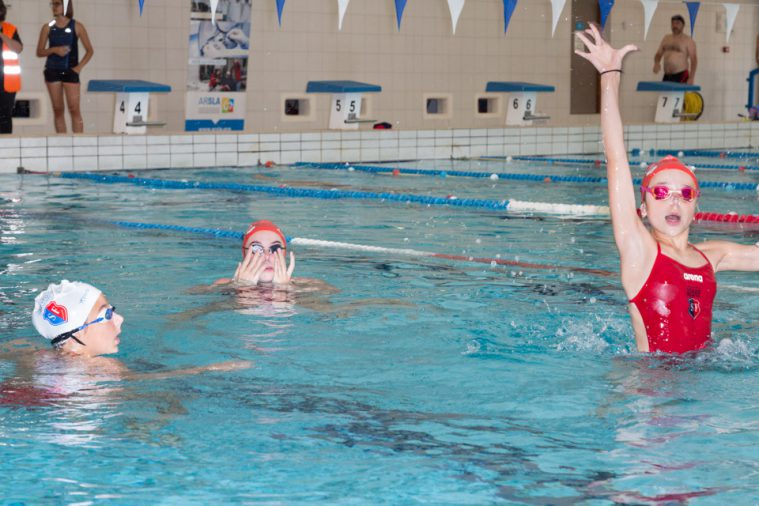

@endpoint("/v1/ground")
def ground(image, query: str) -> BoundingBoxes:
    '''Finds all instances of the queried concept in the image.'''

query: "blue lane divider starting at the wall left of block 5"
[292,162,759,191]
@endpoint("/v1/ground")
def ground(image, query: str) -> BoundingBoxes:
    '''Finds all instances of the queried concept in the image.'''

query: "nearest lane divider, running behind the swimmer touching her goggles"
[104,221,617,277]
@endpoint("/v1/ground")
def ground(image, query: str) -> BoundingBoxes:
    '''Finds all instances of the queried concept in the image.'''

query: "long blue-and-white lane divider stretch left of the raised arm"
[60,172,609,216]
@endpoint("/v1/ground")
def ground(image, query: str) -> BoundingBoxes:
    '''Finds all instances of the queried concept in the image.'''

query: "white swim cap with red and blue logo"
[32,279,101,339]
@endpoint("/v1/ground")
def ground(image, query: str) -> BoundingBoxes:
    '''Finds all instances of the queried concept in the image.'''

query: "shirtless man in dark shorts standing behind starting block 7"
[654,14,698,84]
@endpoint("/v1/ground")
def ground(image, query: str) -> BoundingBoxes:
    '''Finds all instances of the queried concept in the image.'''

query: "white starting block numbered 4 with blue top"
[87,79,171,134]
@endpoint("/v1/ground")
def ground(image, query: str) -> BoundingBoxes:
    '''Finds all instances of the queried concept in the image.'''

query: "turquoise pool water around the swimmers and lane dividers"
[0,159,759,504]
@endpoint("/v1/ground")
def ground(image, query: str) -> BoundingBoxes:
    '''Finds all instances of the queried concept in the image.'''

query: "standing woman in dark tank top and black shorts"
[37,0,95,133]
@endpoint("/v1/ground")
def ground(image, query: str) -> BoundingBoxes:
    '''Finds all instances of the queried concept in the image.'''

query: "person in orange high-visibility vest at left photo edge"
[0,0,24,134]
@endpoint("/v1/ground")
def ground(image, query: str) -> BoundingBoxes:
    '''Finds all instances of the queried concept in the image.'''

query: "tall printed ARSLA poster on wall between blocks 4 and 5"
[185,0,251,132]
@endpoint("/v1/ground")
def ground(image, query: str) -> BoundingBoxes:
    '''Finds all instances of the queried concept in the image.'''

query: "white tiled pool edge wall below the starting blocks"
[0,122,759,173]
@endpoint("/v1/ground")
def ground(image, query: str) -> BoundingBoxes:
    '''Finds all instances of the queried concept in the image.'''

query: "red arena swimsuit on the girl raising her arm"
[630,244,717,353]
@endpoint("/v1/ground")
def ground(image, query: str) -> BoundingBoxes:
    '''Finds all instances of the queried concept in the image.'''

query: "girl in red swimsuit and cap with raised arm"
[576,26,759,353]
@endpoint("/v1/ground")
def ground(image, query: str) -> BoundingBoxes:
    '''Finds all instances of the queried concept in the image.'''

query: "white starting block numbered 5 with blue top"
[306,81,382,130]
